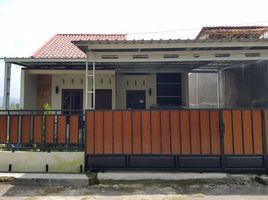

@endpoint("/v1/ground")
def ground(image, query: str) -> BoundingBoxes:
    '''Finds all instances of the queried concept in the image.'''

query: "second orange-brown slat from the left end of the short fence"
[9,115,19,144]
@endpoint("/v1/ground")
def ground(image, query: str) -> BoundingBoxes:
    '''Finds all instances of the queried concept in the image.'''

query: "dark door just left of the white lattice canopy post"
[61,89,83,114]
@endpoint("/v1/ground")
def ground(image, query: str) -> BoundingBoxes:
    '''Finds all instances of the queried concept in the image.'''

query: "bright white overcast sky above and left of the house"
[0,0,268,98]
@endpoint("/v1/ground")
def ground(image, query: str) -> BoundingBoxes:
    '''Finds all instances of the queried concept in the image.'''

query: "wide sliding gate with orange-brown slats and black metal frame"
[86,109,268,172]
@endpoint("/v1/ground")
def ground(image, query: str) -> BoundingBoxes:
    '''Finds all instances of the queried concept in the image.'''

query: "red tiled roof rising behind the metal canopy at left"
[32,34,126,58]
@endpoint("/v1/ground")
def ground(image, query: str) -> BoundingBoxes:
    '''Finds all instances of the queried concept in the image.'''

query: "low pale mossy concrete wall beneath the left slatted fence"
[0,151,84,173]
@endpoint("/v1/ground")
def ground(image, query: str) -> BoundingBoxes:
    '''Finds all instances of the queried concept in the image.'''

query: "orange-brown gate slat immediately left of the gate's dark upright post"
[210,110,221,155]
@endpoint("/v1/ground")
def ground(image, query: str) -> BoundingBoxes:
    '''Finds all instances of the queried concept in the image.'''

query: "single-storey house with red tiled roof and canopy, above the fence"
[4,26,268,110]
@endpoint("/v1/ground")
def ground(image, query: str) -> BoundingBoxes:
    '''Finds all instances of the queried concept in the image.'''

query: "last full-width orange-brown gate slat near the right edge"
[252,110,263,154]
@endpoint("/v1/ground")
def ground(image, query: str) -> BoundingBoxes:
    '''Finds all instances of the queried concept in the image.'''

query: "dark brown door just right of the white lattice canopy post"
[95,89,112,110]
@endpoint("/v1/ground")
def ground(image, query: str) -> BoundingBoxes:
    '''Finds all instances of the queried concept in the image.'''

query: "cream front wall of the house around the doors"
[21,70,188,110]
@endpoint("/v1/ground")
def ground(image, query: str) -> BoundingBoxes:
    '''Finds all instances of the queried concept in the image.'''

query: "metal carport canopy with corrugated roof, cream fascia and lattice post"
[4,39,268,109]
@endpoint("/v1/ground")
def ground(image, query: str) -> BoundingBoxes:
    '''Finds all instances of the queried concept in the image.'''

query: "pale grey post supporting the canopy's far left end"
[3,62,11,110]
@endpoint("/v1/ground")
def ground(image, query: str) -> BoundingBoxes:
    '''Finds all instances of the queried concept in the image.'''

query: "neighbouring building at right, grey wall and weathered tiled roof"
[189,26,268,108]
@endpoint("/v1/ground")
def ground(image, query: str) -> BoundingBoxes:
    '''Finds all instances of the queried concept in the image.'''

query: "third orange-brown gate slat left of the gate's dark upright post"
[190,110,201,154]
